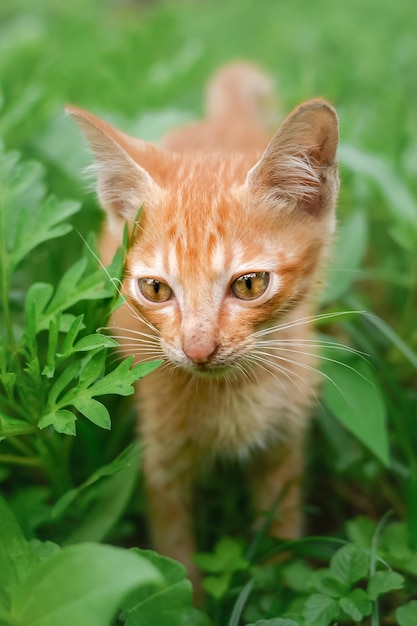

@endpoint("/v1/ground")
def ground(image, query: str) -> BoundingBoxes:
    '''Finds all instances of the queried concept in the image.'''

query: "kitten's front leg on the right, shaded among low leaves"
[250,436,303,539]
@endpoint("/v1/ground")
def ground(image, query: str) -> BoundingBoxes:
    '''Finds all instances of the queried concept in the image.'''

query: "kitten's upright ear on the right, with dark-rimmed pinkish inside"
[247,100,339,216]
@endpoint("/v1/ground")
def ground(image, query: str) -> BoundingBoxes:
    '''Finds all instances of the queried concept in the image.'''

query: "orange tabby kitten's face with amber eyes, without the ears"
[125,155,328,375]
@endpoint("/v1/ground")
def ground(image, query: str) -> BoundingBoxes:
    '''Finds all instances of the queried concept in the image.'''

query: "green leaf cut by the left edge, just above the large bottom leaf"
[0,496,37,598]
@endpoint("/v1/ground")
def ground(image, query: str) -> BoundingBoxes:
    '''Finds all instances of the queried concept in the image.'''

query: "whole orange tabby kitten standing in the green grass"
[68,63,338,582]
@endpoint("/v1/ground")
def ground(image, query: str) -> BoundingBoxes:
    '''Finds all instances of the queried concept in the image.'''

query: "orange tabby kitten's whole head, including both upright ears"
[69,100,338,375]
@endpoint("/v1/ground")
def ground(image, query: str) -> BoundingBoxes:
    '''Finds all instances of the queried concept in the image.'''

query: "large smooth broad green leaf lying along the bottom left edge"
[11,543,163,626]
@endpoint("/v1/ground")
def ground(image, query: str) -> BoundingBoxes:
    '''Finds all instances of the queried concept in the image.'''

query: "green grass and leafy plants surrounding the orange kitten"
[0,0,417,626]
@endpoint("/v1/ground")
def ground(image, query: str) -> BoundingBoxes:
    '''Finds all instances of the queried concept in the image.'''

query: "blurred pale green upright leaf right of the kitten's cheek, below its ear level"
[321,210,368,303]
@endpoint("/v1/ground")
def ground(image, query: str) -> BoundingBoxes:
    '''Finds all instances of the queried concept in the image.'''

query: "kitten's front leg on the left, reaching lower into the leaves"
[144,445,201,596]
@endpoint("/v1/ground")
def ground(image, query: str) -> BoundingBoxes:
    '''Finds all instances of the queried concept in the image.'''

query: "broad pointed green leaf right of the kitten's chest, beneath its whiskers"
[322,359,389,465]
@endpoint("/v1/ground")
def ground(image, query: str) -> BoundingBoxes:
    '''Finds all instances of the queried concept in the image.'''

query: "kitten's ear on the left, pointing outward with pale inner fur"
[65,106,161,227]
